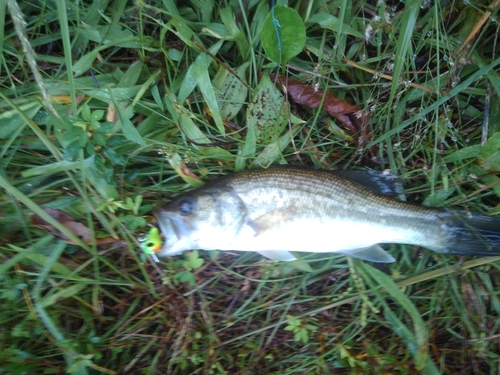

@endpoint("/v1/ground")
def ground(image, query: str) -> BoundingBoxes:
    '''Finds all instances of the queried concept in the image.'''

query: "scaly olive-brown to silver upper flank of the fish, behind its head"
[228,169,443,245]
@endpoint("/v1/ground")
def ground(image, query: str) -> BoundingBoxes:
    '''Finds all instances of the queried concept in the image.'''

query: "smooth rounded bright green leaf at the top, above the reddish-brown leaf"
[261,5,306,65]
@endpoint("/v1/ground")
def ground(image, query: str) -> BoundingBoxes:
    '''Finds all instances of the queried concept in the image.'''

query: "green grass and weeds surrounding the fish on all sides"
[0,0,500,374]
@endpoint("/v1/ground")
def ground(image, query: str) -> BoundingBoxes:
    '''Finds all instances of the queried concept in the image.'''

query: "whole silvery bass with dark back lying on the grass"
[153,166,500,263]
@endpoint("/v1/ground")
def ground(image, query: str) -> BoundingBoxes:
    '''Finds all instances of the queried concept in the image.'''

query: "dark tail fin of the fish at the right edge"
[444,211,500,256]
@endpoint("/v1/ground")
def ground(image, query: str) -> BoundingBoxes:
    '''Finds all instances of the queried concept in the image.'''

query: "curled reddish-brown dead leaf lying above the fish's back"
[271,74,373,151]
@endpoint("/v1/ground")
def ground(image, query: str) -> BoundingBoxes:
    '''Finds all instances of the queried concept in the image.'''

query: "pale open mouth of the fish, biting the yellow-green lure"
[153,209,190,256]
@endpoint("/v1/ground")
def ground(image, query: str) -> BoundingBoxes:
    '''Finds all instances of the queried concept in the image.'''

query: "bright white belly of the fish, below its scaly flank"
[227,220,411,252]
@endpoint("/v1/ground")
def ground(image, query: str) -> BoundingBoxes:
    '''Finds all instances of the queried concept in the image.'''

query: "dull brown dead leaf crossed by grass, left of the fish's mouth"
[31,207,117,245]
